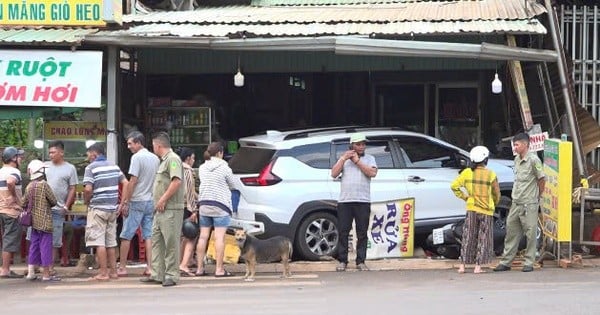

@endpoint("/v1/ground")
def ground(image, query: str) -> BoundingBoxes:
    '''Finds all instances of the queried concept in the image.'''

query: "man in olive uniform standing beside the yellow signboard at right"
[494,133,546,272]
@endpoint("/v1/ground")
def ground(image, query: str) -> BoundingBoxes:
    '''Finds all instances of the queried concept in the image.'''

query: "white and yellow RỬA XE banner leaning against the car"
[367,198,415,259]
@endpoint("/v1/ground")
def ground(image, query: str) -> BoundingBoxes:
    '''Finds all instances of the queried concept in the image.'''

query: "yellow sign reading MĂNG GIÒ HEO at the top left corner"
[0,0,123,26]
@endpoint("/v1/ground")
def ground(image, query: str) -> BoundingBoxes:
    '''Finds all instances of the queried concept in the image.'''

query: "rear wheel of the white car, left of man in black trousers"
[296,212,339,260]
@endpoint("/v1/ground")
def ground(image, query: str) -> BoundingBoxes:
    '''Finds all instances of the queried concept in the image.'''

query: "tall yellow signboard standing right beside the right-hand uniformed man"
[542,139,573,242]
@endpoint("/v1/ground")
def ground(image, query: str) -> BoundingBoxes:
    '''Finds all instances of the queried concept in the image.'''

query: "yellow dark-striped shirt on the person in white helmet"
[450,167,500,215]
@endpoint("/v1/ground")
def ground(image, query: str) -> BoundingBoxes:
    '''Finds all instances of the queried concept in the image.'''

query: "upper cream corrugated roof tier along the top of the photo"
[123,0,546,24]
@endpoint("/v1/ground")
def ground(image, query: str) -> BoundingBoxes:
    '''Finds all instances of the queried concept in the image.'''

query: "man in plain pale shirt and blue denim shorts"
[117,131,160,276]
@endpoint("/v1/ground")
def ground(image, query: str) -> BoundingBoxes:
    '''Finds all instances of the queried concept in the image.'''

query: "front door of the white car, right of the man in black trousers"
[395,136,466,226]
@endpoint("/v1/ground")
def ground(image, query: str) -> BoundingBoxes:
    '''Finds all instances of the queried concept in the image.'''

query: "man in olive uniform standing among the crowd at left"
[140,132,185,287]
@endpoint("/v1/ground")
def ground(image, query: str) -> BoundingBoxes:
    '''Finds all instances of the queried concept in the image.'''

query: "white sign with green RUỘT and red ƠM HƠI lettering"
[0,50,102,108]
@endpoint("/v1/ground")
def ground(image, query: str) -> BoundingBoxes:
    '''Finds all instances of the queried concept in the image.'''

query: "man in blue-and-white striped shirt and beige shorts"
[83,143,127,281]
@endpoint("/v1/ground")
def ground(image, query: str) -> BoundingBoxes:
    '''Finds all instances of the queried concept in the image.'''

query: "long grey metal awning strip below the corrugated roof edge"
[85,33,557,62]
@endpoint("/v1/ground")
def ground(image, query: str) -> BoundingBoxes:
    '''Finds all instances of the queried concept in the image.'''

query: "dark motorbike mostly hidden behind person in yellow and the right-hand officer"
[423,197,542,259]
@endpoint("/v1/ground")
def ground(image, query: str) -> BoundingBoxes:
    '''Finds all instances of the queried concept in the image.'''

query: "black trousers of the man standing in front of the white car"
[337,202,371,265]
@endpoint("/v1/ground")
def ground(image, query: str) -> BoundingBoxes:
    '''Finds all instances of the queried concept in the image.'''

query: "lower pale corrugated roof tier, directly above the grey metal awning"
[104,20,546,37]
